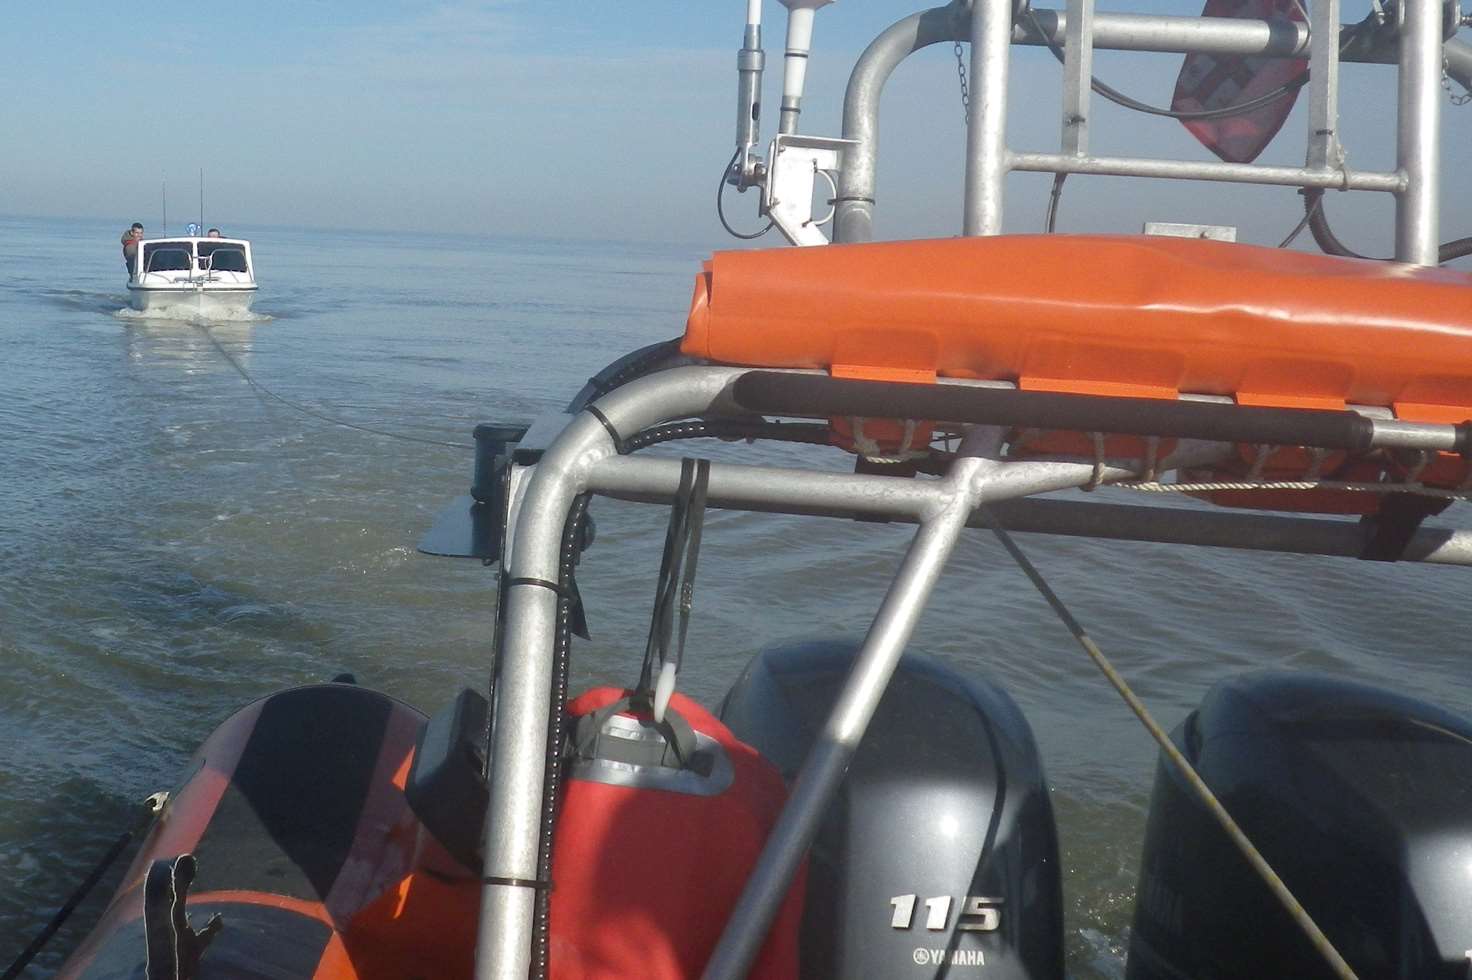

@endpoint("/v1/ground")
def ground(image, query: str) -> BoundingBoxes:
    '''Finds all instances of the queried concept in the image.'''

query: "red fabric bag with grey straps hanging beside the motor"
[551,687,804,980]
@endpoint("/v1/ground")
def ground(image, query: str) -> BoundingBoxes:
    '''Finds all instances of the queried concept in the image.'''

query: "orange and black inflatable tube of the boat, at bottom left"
[60,684,480,980]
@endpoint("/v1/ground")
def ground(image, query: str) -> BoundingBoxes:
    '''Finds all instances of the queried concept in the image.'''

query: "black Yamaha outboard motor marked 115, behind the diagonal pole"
[721,643,1063,980]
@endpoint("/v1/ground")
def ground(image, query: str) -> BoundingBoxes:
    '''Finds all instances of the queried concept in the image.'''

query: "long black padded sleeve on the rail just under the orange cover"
[733,371,1375,452]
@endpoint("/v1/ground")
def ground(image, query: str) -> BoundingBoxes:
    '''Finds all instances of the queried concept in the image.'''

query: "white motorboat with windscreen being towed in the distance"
[128,237,256,316]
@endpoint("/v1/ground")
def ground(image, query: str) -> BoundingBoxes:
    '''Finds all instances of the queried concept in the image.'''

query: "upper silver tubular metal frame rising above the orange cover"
[833,0,1454,258]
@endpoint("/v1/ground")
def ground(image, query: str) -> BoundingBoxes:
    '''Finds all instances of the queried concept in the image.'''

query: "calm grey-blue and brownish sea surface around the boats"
[0,211,1472,977]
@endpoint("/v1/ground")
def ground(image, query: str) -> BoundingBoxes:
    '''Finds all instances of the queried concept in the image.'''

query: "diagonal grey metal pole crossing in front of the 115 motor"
[702,428,1001,980]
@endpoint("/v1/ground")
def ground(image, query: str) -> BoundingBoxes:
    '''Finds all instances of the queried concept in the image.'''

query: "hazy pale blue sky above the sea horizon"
[0,0,1472,252]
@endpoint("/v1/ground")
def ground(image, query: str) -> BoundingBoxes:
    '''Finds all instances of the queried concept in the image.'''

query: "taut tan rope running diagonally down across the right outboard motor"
[980,505,1359,980]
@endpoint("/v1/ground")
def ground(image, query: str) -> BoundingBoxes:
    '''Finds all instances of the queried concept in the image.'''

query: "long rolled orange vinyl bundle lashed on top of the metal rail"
[682,235,1472,509]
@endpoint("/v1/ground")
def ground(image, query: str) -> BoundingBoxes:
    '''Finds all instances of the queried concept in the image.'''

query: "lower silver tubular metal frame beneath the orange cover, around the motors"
[475,366,1472,980]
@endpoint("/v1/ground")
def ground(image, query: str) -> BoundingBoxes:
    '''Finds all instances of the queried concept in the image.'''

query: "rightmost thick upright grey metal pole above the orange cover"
[1395,0,1441,265]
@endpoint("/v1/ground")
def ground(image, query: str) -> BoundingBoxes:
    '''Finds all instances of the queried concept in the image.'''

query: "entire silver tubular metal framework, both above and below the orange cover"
[475,0,1472,980]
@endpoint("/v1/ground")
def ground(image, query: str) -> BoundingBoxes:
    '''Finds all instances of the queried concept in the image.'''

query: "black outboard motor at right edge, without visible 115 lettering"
[1126,672,1472,980]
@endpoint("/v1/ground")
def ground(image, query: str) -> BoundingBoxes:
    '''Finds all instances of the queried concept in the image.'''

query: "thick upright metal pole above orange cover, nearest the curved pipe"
[961,0,1013,235]
